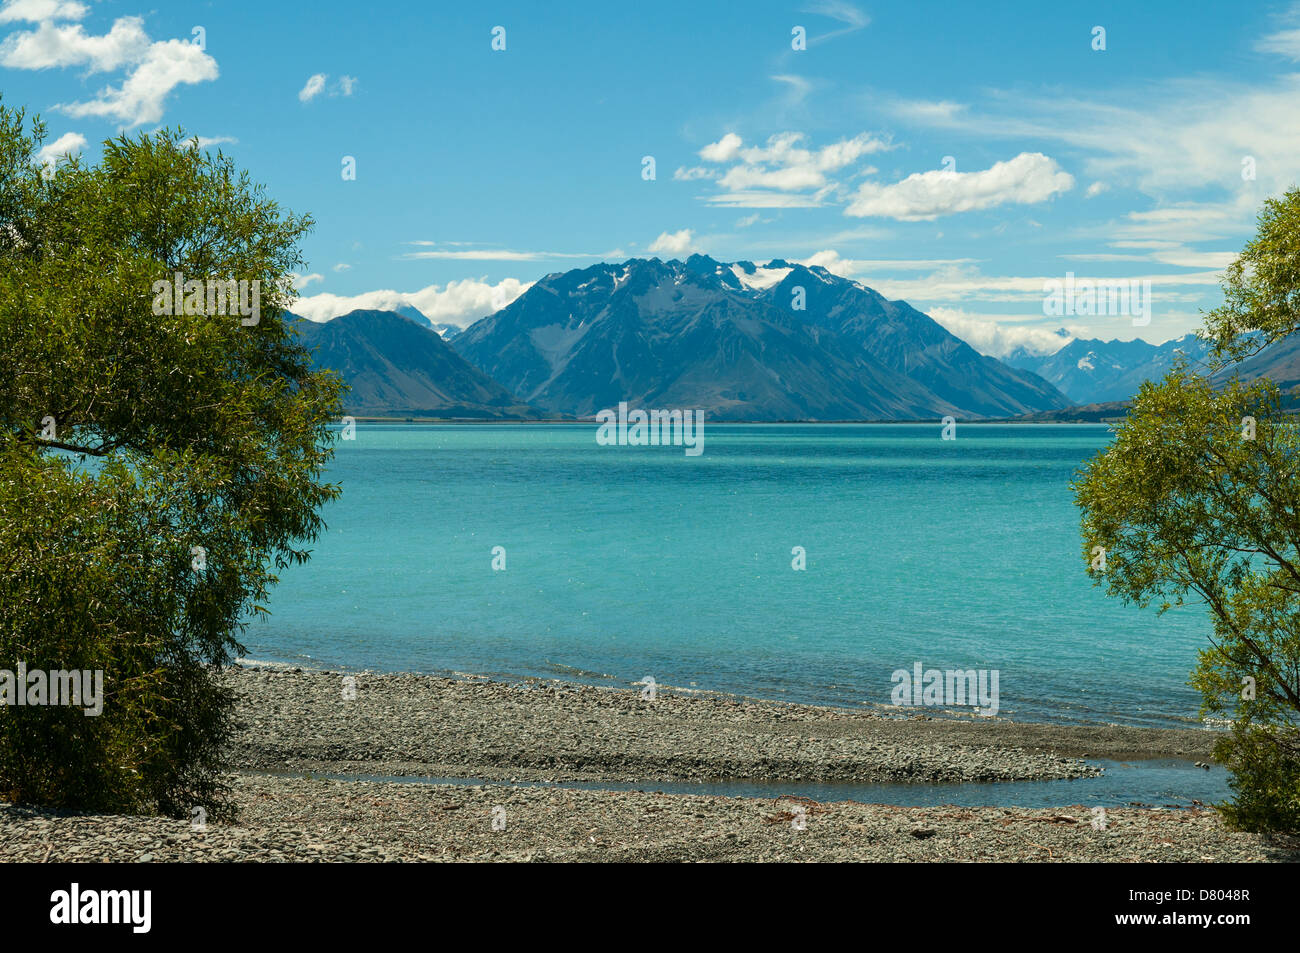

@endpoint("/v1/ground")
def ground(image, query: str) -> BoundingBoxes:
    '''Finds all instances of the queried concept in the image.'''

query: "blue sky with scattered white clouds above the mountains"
[0,0,1300,354]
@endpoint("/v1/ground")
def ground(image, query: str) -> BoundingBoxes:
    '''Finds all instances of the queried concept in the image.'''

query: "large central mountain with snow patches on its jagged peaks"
[452,255,1070,420]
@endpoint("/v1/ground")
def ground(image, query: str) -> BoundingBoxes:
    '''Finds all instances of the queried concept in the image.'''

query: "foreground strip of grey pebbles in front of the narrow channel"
[0,775,1300,863]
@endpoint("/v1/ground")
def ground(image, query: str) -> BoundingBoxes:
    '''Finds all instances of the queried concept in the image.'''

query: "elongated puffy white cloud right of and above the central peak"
[845,152,1074,221]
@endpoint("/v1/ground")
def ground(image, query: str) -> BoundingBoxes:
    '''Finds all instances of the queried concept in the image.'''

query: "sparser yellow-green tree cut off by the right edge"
[1074,190,1300,831]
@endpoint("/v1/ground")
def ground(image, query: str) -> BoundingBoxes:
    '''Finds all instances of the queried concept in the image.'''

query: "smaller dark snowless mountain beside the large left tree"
[294,311,542,419]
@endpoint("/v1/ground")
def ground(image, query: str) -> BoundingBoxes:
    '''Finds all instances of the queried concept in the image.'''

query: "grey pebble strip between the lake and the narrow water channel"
[224,667,1217,784]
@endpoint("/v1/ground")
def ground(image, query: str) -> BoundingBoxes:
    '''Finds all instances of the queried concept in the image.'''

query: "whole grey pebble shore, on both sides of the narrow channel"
[0,660,1300,862]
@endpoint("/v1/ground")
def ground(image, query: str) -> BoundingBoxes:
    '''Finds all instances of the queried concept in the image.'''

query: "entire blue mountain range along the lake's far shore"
[289,255,1300,421]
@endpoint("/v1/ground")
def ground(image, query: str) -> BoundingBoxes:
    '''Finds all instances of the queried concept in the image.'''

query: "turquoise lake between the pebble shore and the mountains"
[243,421,1209,727]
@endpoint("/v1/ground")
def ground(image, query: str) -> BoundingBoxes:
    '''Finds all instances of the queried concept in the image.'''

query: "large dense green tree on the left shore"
[0,103,342,816]
